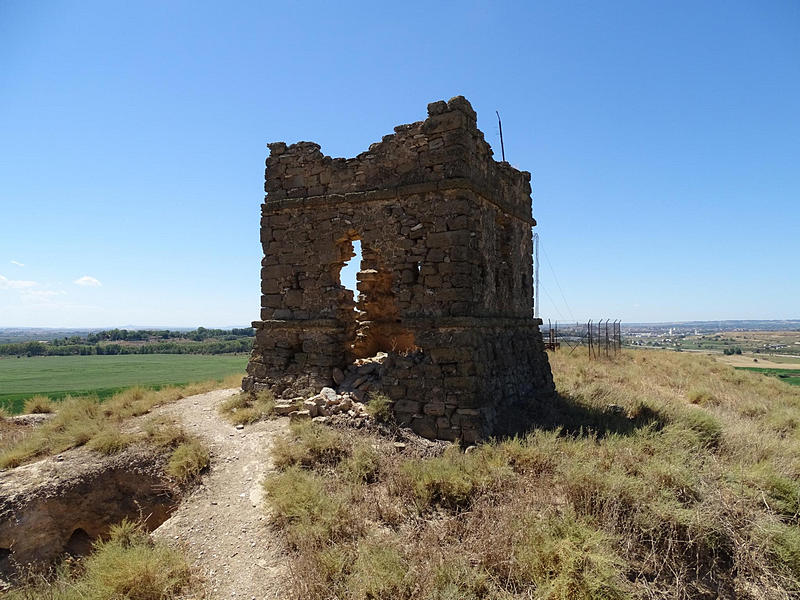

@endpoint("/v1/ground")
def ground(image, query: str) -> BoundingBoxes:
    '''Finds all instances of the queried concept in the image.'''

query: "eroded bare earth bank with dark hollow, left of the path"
[0,446,179,578]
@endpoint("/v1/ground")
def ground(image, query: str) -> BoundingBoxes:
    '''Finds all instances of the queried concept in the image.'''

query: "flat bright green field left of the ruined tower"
[0,354,247,412]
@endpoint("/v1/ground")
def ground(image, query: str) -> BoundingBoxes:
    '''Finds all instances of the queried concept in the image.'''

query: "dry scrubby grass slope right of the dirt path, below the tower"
[266,351,800,600]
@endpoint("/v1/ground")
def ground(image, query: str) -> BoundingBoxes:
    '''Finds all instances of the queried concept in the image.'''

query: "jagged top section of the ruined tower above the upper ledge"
[264,96,534,223]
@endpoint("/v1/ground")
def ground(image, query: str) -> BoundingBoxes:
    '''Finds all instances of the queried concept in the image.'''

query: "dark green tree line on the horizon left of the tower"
[0,327,255,356]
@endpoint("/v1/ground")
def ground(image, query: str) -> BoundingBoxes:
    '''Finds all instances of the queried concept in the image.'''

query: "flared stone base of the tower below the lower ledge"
[243,317,555,442]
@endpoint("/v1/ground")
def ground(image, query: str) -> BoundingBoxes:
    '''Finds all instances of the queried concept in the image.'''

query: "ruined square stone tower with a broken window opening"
[243,96,554,441]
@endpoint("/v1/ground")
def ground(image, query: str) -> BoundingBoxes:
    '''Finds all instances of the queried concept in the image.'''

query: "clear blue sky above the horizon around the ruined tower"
[0,0,800,327]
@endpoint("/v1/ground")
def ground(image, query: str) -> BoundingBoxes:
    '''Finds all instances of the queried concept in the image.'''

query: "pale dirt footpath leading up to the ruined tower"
[154,390,288,600]
